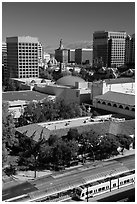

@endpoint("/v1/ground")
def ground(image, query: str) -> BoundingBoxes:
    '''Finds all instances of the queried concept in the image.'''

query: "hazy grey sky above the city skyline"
[2,2,135,47]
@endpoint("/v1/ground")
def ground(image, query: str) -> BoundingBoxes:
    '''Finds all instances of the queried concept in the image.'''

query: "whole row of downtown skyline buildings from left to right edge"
[2,31,135,78]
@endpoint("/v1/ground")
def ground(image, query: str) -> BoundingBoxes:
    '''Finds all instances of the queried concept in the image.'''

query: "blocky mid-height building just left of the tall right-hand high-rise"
[75,48,93,64]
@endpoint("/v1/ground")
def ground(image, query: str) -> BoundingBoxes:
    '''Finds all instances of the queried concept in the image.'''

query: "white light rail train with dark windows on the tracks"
[73,171,135,200]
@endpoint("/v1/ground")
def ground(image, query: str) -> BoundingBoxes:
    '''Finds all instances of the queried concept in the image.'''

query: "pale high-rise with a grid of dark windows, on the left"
[6,36,39,78]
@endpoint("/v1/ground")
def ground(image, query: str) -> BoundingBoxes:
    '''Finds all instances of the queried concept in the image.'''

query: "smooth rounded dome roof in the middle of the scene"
[56,76,85,86]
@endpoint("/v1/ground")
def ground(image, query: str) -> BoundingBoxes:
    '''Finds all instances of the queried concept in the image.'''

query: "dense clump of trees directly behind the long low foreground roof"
[17,100,83,126]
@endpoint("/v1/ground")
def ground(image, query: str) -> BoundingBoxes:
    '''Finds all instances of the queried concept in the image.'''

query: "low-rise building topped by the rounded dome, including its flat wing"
[35,76,91,104]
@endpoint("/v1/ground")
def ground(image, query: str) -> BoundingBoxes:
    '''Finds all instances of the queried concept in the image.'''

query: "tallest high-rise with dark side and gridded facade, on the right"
[93,31,126,67]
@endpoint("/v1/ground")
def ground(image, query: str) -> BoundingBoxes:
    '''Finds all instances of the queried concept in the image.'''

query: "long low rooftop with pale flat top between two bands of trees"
[16,117,135,141]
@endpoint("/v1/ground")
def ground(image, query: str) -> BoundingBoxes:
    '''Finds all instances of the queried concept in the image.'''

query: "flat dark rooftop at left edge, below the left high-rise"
[2,91,54,101]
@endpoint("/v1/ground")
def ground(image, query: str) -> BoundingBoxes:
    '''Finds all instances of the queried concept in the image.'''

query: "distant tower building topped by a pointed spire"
[55,40,68,64]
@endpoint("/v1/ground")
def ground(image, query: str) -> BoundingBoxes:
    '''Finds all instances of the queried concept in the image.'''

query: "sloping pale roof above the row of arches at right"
[94,91,135,106]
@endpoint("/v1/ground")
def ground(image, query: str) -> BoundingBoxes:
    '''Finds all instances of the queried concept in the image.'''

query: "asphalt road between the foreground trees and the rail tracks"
[2,155,135,201]
